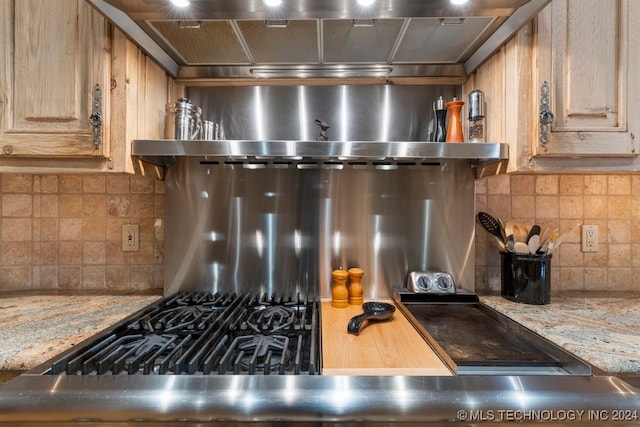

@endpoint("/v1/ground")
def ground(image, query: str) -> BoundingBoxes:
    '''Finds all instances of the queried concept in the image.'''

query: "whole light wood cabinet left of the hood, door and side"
[0,0,179,172]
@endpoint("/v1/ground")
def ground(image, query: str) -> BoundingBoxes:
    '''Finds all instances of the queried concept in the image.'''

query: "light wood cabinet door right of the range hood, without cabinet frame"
[533,0,640,156]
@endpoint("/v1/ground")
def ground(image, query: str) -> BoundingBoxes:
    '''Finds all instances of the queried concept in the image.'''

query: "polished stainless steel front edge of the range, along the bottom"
[0,375,640,425]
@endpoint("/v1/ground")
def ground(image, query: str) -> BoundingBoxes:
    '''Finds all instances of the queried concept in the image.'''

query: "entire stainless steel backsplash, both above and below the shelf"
[165,86,474,298]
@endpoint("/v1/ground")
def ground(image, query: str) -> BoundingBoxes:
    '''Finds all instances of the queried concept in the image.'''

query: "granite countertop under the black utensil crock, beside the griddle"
[480,292,640,374]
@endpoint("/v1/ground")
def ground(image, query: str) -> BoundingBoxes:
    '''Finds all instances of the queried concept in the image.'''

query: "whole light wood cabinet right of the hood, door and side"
[463,0,640,171]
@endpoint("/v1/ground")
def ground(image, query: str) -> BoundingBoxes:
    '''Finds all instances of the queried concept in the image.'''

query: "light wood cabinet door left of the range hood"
[0,0,110,158]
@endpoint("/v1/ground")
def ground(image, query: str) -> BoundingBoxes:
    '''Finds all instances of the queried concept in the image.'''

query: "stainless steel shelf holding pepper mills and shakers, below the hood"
[132,139,509,162]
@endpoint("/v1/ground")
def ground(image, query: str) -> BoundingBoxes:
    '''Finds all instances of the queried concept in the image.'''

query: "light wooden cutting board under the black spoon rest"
[321,300,453,376]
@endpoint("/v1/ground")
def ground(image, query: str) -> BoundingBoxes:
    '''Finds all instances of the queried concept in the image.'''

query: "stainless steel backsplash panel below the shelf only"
[165,157,474,298]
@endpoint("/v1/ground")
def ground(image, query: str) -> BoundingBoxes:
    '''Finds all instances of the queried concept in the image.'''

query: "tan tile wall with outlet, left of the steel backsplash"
[0,174,164,291]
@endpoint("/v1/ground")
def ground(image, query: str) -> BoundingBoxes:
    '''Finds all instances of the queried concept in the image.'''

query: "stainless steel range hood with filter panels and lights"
[87,0,550,81]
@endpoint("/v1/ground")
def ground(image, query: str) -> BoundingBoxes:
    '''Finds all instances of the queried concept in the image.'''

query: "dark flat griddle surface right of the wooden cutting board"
[406,303,559,366]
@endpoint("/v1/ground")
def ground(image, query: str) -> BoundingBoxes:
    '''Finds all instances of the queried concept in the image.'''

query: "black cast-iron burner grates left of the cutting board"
[50,293,320,375]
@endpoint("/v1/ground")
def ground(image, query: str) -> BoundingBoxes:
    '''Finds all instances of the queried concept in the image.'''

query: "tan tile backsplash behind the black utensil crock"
[476,174,640,294]
